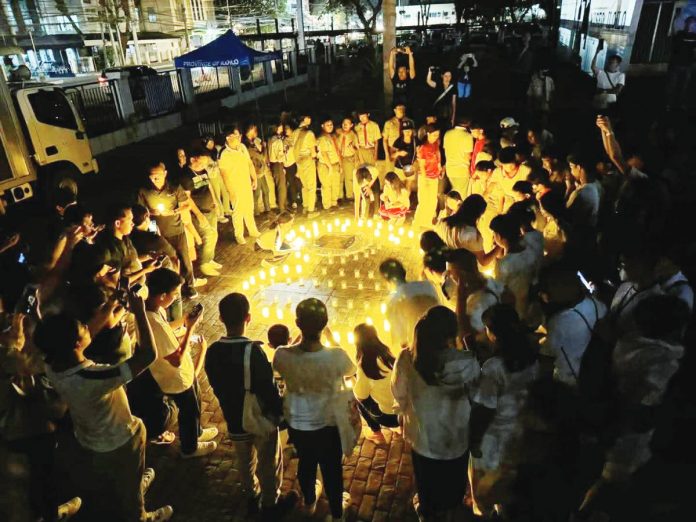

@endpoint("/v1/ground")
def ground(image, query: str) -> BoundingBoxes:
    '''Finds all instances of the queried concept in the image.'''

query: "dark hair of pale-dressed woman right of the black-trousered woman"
[482,304,538,373]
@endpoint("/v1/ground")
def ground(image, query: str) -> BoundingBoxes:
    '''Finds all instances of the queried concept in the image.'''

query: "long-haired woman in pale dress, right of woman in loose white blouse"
[469,304,539,516]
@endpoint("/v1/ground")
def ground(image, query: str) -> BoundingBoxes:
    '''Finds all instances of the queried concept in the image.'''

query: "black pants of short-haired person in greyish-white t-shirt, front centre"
[288,426,342,518]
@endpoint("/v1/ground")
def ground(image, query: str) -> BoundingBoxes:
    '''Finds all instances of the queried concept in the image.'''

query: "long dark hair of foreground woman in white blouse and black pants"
[413,306,458,386]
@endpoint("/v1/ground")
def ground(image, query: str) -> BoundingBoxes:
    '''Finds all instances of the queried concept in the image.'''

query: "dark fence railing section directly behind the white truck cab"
[65,80,124,136]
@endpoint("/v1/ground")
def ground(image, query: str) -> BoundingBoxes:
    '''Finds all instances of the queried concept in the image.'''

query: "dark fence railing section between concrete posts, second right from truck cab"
[130,70,183,119]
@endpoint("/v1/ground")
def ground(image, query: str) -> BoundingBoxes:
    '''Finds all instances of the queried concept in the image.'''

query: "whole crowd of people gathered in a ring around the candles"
[0,37,694,522]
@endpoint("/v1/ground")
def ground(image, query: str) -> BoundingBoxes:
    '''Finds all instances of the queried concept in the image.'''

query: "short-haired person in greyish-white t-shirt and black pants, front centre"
[273,298,356,521]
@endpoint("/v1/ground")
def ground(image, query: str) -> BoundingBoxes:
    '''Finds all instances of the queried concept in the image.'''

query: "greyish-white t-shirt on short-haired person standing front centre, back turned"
[273,345,356,431]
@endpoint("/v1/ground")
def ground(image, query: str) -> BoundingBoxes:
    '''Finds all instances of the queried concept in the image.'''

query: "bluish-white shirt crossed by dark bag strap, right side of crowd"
[541,297,607,386]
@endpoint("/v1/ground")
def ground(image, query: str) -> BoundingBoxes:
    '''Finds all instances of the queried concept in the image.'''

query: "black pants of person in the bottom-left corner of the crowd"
[8,433,58,522]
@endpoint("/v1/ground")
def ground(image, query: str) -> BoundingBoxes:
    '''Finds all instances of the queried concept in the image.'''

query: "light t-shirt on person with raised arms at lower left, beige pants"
[46,360,141,453]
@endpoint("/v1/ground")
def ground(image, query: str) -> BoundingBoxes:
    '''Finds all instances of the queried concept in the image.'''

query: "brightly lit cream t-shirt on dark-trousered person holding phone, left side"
[147,310,195,394]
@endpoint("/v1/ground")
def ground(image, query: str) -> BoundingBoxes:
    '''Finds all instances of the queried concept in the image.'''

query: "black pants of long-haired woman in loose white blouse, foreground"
[411,444,469,516]
